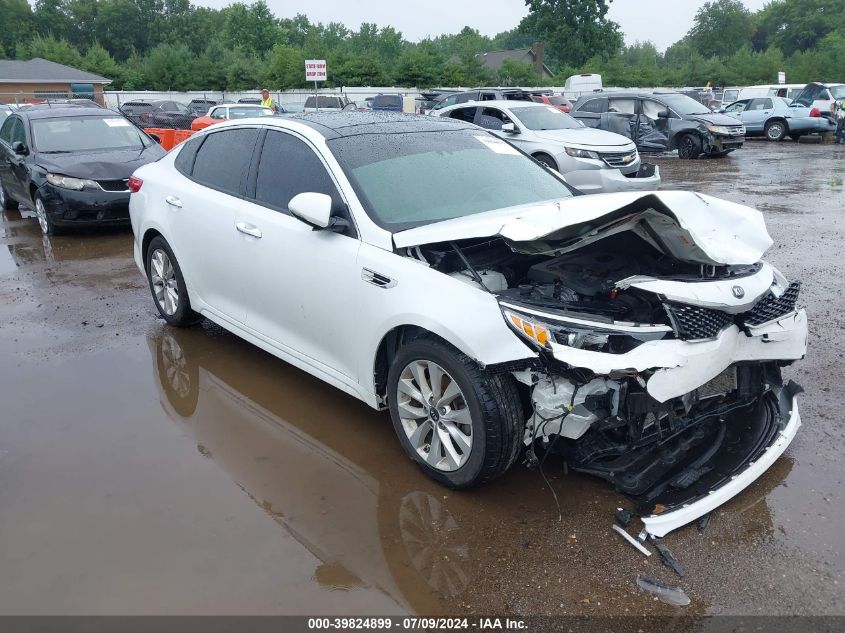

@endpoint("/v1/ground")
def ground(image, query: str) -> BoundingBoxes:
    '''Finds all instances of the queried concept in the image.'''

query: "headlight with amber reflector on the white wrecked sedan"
[502,307,668,354]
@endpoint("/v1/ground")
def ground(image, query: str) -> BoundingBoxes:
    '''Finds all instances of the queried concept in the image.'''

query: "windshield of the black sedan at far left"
[32,117,148,152]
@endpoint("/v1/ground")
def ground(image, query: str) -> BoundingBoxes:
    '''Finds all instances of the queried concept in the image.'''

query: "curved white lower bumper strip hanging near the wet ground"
[641,384,801,538]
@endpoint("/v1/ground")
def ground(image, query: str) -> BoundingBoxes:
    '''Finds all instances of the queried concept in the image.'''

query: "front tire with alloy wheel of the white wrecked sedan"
[387,337,525,488]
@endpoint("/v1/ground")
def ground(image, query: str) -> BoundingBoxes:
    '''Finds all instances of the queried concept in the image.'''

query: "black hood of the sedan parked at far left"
[36,145,166,180]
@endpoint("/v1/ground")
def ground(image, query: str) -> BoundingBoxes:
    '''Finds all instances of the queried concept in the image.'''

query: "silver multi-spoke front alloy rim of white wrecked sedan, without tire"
[396,360,472,472]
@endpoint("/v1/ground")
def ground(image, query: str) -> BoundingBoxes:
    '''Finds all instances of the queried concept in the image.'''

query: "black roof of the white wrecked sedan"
[249,112,478,140]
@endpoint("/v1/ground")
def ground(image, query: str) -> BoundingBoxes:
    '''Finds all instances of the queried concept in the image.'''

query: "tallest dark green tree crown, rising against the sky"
[519,0,623,66]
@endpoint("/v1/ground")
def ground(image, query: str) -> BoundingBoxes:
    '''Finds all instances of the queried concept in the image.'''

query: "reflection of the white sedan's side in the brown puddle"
[148,328,471,613]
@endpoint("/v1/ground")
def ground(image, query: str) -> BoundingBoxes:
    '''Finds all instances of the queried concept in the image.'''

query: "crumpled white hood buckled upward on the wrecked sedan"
[393,191,772,265]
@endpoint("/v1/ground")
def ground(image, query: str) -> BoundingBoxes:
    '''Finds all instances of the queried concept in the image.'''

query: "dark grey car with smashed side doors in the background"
[572,92,745,159]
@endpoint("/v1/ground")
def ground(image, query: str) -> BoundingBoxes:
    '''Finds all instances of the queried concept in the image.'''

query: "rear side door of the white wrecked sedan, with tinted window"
[162,127,259,324]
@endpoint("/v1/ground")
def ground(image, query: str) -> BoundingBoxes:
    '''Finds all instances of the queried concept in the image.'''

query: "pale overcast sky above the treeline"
[199,0,768,50]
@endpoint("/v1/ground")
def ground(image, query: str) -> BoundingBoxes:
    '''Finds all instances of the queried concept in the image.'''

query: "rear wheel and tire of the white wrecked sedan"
[146,236,202,327]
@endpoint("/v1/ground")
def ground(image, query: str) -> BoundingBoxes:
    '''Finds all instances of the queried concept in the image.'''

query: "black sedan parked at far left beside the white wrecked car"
[0,108,165,235]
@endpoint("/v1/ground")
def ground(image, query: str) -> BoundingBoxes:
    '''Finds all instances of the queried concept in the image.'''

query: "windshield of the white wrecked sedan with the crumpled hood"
[328,130,572,231]
